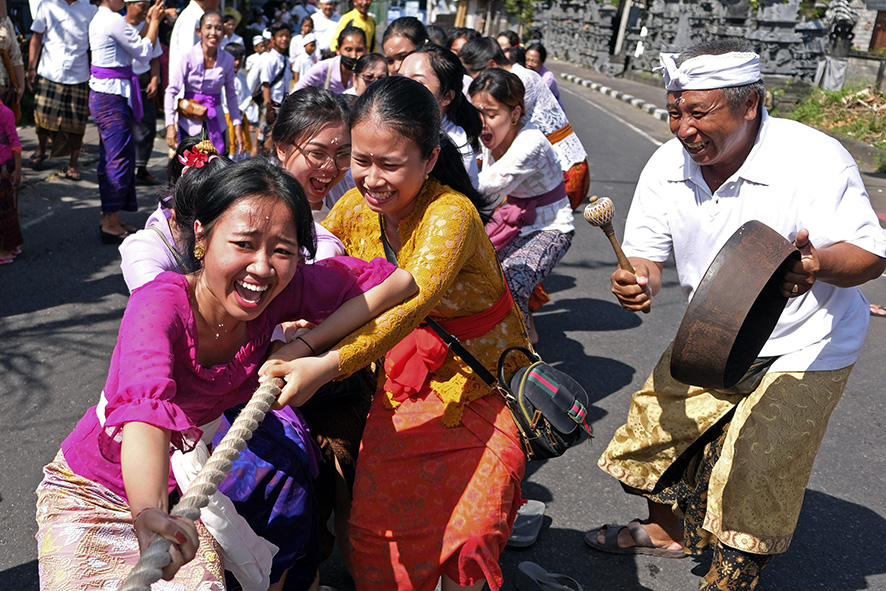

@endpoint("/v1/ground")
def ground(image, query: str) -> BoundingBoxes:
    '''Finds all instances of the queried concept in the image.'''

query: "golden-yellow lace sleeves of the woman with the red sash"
[327,182,488,375]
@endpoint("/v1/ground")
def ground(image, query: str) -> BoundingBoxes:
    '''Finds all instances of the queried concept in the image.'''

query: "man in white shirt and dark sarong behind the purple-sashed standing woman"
[124,0,163,185]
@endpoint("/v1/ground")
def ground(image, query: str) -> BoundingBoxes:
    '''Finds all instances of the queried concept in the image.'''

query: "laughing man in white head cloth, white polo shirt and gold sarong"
[585,40,886,591]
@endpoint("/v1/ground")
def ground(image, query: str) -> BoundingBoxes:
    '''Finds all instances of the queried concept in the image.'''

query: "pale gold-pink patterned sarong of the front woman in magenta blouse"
[37,451,225,591]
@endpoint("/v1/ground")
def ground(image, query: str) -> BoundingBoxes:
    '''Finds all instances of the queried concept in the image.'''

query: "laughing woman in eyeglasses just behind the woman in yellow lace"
[271,87,375,566]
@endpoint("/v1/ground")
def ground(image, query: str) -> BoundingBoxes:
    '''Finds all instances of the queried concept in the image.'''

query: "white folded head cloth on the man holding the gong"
[656,51,761,92]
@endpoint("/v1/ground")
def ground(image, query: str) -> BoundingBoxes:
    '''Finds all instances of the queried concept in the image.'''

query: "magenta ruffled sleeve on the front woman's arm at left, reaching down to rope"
[99,273,202,462]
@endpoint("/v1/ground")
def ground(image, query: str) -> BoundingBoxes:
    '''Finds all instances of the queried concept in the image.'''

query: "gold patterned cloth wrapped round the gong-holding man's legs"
[598,347,852,554]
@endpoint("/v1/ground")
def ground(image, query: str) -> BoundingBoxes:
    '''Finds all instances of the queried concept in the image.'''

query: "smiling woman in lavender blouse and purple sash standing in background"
[165,10,243,154]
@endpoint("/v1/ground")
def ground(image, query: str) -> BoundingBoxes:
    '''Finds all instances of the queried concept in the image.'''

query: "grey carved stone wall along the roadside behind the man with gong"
[536,0,827,81]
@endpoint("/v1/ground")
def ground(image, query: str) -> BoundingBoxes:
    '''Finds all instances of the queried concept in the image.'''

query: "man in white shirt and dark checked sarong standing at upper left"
[26,0,97,180]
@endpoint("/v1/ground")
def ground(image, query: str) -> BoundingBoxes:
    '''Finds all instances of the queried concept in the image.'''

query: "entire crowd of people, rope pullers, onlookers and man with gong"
[8,0,886,591]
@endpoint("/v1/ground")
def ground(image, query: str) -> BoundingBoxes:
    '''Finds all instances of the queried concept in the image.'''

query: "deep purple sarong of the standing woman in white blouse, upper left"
[89,91,138,214]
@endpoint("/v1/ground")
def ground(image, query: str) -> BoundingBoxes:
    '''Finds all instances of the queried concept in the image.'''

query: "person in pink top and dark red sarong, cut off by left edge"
[0,98,24,265]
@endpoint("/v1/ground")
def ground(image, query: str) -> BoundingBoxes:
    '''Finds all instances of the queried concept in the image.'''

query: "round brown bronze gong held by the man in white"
[671,220,800,390]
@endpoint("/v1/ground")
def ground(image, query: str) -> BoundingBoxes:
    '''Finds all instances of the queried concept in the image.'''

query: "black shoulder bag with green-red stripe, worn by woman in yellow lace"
[378,214,594,460]
